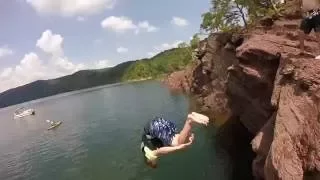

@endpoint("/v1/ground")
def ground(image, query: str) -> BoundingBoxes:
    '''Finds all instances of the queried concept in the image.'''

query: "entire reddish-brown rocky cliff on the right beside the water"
[165,16,320,180]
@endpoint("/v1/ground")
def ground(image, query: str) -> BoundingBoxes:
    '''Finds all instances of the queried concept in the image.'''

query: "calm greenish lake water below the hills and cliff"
[0,81,230,180]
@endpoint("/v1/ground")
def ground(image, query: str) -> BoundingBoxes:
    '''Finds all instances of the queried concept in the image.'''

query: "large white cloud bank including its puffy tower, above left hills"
[0,30,114,92]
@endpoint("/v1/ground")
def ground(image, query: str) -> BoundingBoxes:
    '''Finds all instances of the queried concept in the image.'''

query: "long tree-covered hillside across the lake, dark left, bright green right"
[0,48,191,108]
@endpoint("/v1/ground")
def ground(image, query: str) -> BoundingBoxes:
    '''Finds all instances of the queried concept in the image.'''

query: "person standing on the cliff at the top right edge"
[299,0,320,59]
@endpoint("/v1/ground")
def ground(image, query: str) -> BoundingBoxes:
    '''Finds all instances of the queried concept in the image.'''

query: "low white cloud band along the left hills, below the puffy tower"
[0,52,111,92]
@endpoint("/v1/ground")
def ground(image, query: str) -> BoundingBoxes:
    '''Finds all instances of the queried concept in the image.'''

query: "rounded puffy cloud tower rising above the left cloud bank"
[36,30,63,55]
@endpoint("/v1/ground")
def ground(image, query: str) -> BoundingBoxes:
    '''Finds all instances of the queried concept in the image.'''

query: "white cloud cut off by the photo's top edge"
[26,0,116,16]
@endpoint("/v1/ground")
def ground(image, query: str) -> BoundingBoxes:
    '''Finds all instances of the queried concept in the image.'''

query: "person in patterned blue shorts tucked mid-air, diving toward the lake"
[141,112,209,168]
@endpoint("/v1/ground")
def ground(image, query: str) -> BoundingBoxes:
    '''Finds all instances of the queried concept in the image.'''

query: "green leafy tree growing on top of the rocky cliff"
[200,0,276,32]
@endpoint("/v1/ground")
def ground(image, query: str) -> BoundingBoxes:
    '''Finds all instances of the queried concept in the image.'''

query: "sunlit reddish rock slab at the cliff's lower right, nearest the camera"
[265,58,320,180]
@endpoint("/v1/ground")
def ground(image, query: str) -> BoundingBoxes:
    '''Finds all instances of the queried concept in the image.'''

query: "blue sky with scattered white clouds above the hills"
[0,0,210,92]
